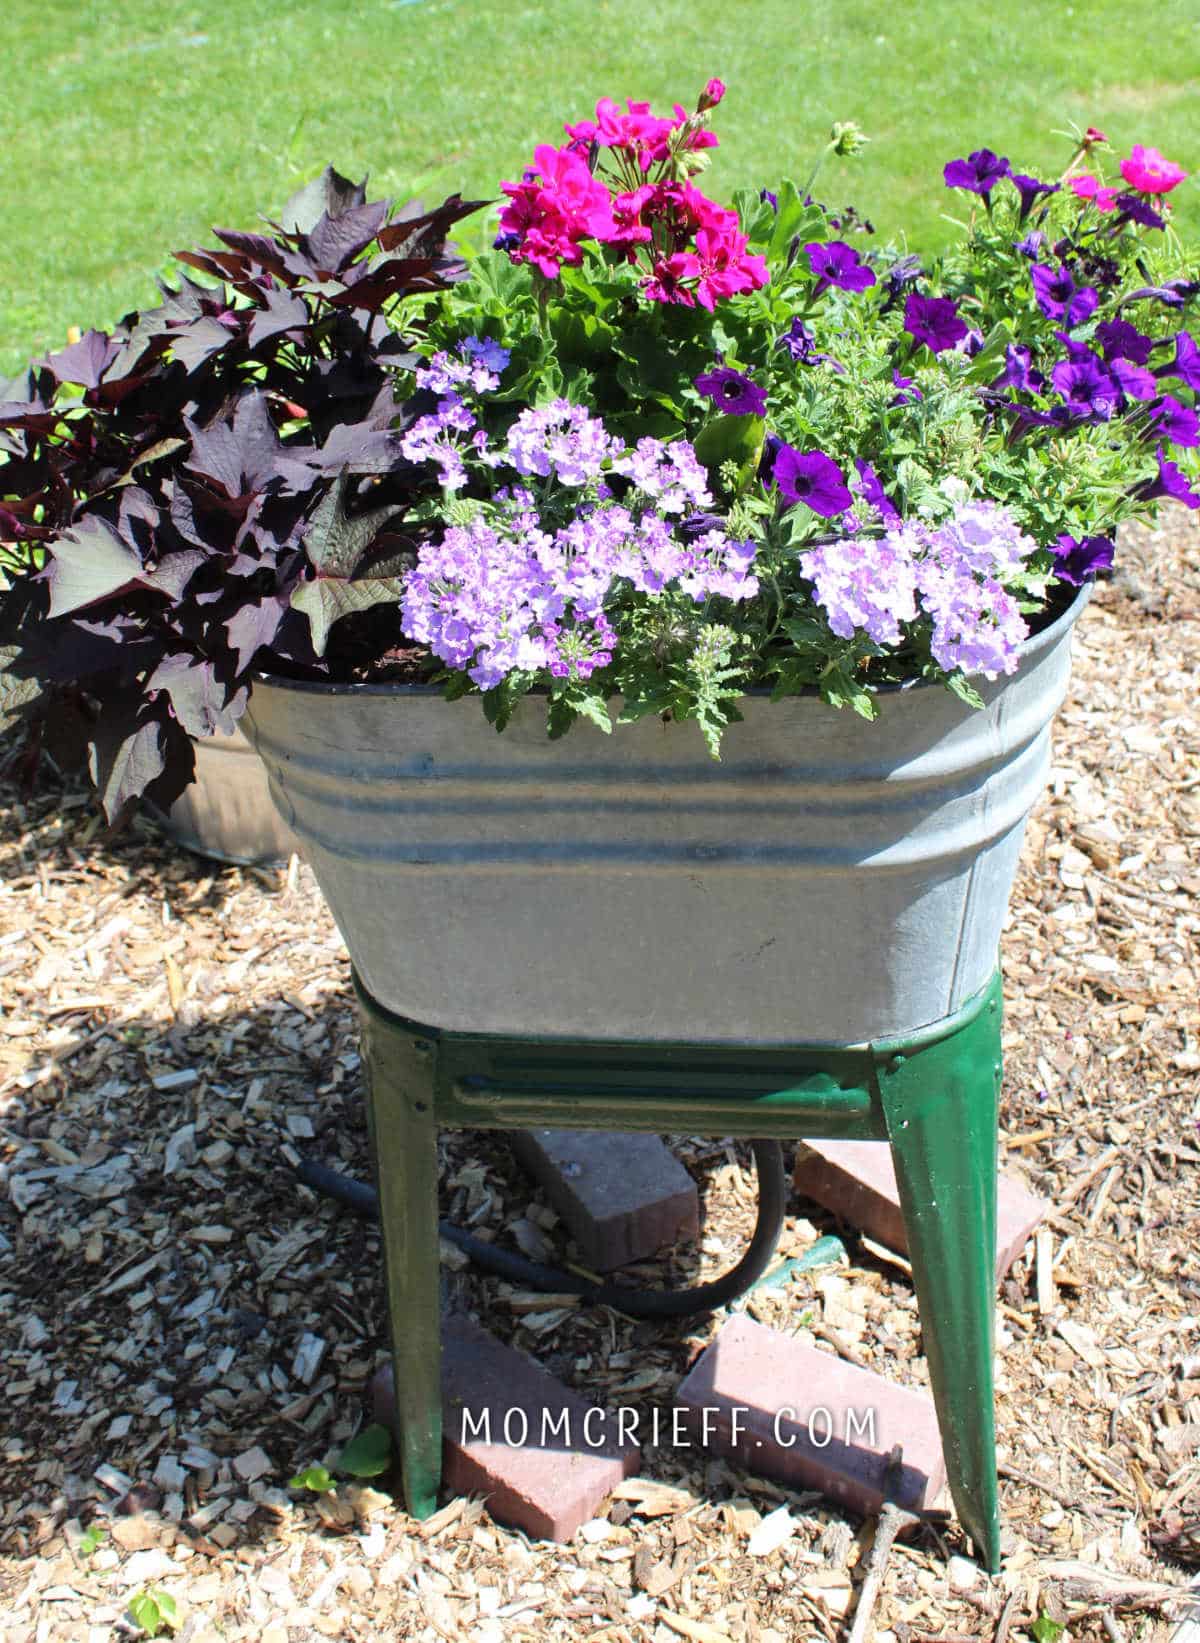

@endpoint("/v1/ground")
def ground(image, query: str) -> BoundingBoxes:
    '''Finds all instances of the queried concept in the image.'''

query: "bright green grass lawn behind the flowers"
[0,0,1200,373]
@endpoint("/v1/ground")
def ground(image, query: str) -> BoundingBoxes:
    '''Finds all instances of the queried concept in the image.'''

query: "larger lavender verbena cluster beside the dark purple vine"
[401,337,758,690]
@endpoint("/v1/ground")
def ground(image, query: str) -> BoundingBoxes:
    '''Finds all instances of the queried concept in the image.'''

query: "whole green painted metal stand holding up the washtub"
[355,974,1001,1571]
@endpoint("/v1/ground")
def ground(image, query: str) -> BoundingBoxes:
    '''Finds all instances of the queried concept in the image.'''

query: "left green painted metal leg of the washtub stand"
[362,1010,442,1518]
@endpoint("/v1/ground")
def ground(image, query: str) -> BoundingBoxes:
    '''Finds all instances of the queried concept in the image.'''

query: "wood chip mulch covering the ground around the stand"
[0,518,1200,1643]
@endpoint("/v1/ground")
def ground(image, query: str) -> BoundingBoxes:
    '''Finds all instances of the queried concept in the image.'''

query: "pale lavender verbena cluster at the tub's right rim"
[799,501,1037,679]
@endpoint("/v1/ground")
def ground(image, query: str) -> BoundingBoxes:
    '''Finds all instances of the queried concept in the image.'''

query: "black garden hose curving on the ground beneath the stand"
[296,1140,787,1318]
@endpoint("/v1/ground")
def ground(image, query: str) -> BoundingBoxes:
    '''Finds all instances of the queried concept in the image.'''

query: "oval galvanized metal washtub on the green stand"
[243,590,1087,1045]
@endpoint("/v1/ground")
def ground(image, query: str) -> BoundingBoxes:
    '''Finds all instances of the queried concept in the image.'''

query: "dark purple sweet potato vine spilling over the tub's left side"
[0,168,482,820]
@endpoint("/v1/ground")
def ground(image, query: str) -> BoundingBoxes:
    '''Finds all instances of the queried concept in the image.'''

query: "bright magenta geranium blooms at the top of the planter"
[496,79,769,311]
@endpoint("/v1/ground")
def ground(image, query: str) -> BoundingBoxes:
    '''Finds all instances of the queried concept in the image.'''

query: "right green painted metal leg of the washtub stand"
[878,976,999,1572]
